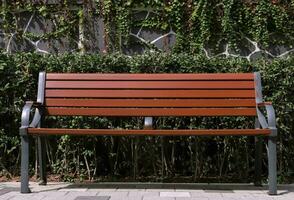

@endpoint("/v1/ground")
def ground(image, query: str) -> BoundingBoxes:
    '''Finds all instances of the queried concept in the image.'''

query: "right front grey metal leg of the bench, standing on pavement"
[268,137,277,195]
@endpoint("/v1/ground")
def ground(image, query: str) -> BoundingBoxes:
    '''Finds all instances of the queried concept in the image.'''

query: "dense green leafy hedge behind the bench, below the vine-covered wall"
[0,53,294,182]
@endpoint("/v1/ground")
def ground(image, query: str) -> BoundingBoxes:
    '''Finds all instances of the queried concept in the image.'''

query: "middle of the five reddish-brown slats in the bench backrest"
[45,89,255,98]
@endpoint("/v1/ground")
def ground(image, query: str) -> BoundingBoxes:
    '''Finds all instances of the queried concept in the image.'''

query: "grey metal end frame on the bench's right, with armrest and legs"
[254,72,278,195]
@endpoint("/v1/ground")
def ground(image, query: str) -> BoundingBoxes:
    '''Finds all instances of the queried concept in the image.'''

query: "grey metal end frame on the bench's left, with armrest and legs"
[19,72,46,193]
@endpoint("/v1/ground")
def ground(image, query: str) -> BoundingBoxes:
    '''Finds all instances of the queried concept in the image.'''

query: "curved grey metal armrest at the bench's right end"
[256,102,277,136]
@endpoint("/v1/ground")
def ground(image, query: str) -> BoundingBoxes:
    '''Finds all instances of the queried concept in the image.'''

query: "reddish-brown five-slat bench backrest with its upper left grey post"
[38,72,256,117]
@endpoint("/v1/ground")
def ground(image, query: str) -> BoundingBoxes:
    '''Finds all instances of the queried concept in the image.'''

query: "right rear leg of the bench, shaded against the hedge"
[254,136,263,186]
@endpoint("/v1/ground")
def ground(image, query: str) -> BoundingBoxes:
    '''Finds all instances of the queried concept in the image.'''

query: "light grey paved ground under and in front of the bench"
[0,182,294,200]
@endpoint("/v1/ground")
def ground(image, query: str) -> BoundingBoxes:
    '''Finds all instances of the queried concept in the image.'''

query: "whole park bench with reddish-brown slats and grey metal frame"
[20,72,277,194]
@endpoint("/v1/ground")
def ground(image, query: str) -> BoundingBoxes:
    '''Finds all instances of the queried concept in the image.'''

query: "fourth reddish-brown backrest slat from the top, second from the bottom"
[45,98,256,107]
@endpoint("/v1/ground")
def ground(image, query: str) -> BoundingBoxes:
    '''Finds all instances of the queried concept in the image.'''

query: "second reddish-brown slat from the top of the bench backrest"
[46,81,254,89]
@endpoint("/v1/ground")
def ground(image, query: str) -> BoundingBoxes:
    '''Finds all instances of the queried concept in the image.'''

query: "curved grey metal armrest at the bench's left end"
[20,101,42,135]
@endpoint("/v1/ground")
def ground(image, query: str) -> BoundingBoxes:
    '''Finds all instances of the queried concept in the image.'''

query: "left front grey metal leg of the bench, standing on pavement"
[20,135,31,193]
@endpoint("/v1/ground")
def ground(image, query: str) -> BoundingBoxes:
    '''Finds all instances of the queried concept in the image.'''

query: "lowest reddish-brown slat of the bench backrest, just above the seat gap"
[47,107,256,117]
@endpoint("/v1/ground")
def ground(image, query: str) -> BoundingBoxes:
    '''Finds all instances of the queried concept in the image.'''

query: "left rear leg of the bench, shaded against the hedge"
[38,136,47,185]
